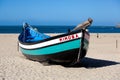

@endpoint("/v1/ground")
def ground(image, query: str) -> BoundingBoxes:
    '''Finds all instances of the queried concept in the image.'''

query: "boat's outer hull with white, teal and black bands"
[19,31,89,63]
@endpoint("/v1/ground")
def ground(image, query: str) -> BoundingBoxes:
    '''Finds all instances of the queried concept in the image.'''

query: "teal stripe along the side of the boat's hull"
[21,39,81,55]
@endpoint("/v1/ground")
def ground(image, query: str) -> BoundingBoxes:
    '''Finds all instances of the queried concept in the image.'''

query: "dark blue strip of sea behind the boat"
[0,25,120,34]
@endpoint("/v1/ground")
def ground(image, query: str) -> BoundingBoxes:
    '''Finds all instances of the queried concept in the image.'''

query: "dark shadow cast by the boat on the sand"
[46,58,120,68]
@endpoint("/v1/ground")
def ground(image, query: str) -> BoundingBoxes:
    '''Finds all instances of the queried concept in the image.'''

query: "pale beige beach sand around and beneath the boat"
[0,34,120,80]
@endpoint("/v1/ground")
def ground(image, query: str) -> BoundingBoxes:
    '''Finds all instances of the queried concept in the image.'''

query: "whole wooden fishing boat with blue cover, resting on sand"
[18,19,92,63]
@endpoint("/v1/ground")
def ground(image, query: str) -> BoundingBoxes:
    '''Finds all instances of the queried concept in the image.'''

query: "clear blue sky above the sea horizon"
[0,0,120,26]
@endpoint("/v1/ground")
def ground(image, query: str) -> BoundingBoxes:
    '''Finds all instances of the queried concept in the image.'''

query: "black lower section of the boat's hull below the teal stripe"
[23,49,79,63]
